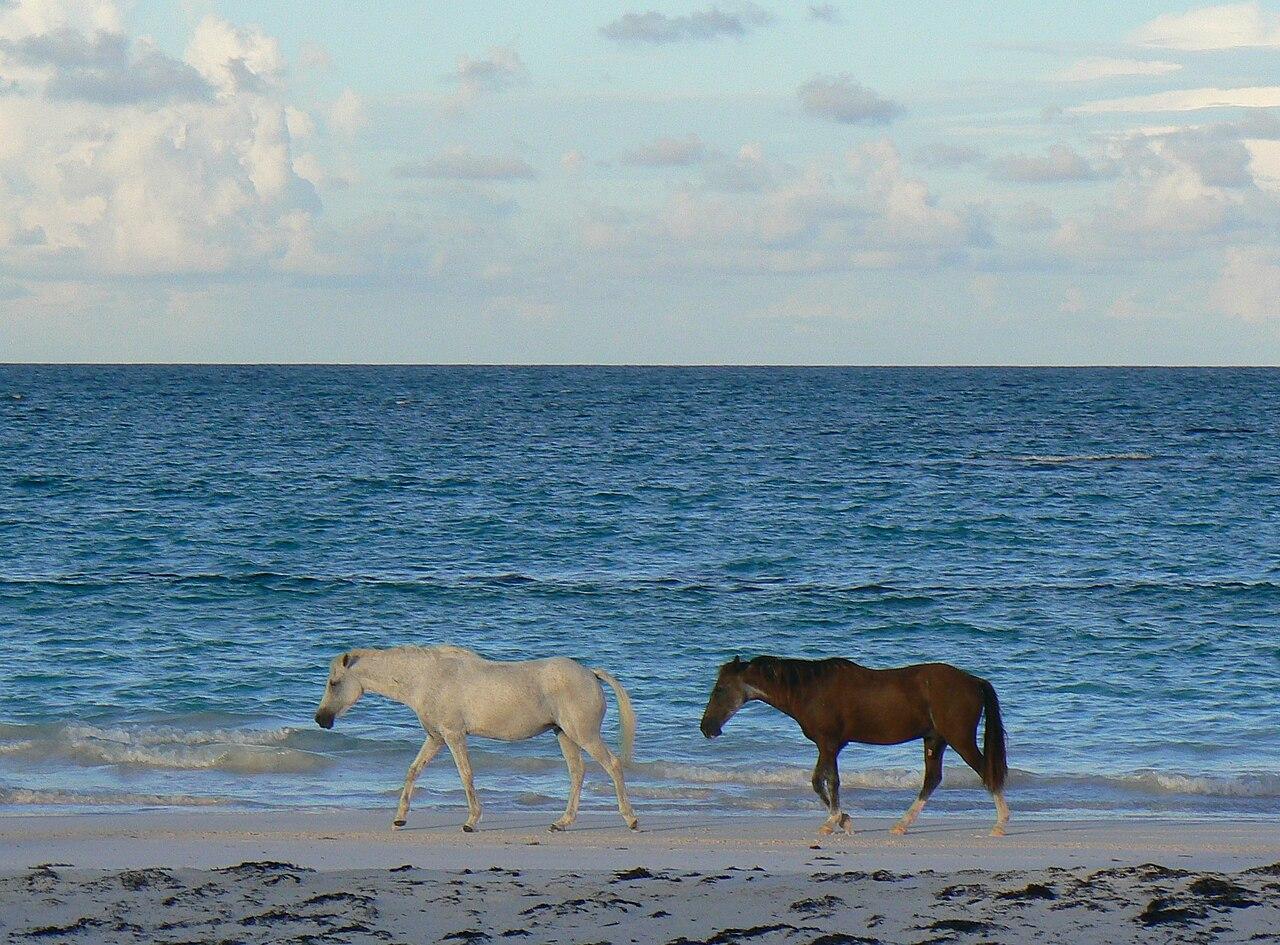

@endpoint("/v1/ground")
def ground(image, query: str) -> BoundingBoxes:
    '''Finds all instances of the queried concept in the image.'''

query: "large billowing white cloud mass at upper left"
[0,0,321,280]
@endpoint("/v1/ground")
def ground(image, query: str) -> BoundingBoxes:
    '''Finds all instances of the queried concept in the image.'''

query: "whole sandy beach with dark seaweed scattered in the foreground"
[0,809,1280,945]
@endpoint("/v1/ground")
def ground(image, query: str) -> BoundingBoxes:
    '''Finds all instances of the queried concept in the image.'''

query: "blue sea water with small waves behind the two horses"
[0,366,1280,816]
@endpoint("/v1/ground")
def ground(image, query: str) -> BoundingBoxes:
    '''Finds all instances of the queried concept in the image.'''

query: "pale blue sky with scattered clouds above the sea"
[0,0,1280,365]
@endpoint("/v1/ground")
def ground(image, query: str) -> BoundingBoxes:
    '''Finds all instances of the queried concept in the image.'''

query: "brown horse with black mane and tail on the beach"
[701,657,1009,836]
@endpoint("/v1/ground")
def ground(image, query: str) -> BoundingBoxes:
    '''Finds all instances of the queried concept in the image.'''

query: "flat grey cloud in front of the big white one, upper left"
[0,27,212,105]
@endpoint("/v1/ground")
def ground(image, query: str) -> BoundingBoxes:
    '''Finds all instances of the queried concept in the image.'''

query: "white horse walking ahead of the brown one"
[316,645,637,834]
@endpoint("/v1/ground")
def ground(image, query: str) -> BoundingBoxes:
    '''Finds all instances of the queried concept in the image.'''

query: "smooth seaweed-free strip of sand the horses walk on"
[0,808,1280,872]
